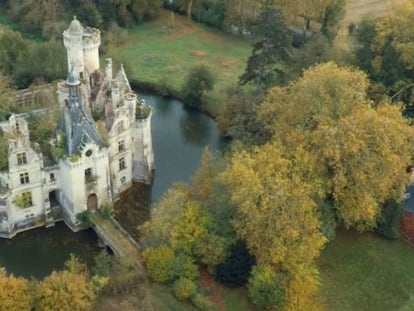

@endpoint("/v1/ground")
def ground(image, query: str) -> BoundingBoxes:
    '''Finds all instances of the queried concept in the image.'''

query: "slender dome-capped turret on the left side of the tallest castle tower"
[63,16,85,78]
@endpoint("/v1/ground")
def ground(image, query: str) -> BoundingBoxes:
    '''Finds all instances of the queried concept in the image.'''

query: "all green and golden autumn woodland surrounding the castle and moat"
[0,0,414,311]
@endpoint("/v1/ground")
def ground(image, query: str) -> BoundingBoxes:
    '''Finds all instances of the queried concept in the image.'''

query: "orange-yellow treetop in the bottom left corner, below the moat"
[0,267,33,311]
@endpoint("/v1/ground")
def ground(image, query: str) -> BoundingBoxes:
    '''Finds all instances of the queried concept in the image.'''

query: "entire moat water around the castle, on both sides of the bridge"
[0,94,225,278]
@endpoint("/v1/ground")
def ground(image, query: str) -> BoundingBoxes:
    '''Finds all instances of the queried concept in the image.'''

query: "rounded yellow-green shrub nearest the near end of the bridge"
[142,245,175,283]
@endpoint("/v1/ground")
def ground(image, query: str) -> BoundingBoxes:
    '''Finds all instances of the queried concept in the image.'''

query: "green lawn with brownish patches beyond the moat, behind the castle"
[108,11,251,113]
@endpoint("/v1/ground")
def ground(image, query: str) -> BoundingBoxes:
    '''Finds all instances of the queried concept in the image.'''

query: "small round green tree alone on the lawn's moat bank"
[182,64,215,106]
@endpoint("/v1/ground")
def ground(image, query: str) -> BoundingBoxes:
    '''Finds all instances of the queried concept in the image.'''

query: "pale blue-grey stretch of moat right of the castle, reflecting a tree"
[140,94,225,202]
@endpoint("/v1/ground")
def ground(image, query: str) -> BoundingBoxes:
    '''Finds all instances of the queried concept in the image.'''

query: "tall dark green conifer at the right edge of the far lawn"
[239,8,292,92]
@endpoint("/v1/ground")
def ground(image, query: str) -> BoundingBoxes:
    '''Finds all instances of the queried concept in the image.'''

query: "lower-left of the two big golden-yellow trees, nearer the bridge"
[222,142,326,273]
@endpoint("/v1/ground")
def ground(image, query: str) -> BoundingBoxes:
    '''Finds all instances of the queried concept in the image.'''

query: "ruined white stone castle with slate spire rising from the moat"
[0,17,154,238]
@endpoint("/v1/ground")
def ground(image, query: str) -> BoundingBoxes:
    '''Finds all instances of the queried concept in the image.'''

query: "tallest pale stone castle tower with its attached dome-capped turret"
[63,16,101,79]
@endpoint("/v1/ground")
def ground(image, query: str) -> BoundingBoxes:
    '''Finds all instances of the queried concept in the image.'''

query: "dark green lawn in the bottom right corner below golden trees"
[319,230,414,311]
